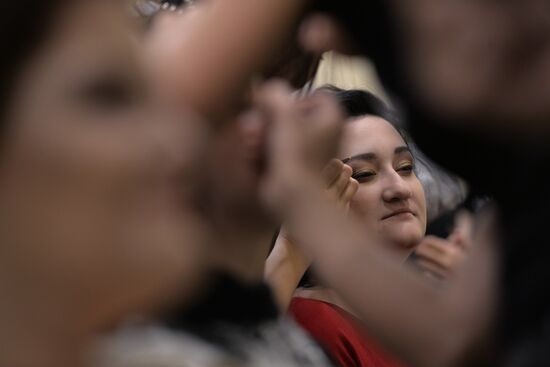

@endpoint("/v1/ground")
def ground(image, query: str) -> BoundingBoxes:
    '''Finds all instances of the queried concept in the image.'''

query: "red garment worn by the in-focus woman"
[289,297,403,367]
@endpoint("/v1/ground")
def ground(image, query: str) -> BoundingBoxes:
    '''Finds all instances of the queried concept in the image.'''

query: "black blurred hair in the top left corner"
[0,0,68,118]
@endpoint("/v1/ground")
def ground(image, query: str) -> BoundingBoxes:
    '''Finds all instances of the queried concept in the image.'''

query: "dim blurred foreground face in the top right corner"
[388,0,550,131]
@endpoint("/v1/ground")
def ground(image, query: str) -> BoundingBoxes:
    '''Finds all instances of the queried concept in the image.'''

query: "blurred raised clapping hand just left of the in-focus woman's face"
[254,81,344,212]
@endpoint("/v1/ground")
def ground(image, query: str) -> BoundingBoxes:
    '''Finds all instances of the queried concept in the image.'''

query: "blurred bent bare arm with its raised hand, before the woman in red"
[262,82,497,367]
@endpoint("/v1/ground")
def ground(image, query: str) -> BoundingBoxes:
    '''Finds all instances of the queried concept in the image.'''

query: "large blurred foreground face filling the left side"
[0,0,207,327]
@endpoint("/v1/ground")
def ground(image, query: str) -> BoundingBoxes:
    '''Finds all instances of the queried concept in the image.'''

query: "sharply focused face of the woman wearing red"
[340,116,426,256]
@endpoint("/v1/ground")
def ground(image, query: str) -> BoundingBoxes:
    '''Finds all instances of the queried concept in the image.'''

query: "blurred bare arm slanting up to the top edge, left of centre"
[149,0,309,121]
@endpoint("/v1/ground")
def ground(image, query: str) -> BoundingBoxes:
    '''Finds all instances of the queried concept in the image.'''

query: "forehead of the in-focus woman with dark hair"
[340,116,405,158]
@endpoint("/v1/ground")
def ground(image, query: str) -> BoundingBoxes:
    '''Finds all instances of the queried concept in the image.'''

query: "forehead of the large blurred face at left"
[21,0,141,89]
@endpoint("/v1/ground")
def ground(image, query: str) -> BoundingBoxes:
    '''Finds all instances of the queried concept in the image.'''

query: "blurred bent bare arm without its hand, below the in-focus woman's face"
[287,182,496,366]
